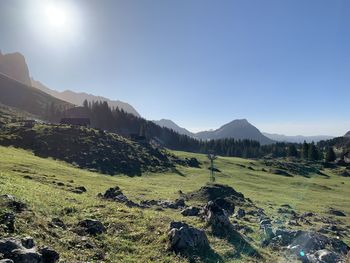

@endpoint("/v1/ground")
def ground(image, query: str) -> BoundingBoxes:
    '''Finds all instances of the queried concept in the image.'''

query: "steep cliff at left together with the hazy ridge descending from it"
[0,52,140,117]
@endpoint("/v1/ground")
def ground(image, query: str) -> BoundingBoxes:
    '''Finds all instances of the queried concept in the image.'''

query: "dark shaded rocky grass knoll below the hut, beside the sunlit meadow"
[0,121,178,175]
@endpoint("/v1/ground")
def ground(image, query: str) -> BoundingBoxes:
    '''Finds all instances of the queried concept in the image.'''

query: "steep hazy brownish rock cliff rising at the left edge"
[0,52,31,86]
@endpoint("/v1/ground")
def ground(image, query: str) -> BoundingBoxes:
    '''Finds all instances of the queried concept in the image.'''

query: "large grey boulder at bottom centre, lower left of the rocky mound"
[168,222,210,256]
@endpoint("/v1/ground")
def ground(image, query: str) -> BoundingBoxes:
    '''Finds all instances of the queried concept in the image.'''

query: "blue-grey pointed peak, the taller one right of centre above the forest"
[195,119,274,144]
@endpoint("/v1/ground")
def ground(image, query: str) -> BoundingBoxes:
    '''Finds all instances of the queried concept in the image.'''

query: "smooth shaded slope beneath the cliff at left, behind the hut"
[0,73,73,116]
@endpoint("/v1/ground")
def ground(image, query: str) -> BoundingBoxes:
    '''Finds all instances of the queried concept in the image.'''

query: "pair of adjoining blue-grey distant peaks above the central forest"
[153,119,274,144]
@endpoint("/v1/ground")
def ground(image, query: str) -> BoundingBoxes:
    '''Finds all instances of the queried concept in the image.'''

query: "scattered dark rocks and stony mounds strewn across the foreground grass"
[0,184,350,263]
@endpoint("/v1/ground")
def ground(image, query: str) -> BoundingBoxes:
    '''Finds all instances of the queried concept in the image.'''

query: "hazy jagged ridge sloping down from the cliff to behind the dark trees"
[31,79,140,117]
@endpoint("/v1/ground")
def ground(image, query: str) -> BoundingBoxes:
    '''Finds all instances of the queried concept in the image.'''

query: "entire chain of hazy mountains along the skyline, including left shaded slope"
[0,52,344,145]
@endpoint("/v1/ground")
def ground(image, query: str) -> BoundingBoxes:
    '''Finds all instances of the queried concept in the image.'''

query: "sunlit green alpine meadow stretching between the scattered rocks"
[0,147,350,262]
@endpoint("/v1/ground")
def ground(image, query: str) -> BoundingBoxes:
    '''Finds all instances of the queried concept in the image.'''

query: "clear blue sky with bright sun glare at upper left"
[0,0,350,135]
